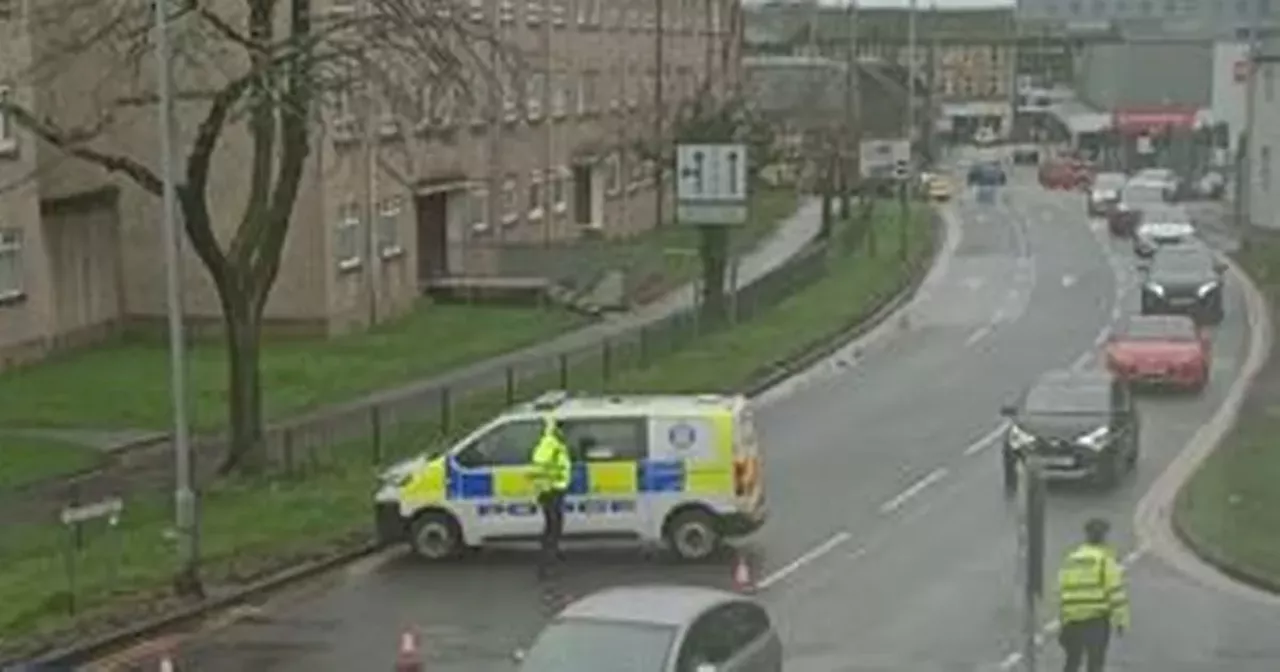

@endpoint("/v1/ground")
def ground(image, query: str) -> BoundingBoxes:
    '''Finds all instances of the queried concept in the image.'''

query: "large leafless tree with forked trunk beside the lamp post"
[0,0,507,472]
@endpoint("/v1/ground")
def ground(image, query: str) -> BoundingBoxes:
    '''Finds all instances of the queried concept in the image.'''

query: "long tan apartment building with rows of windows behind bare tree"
[0,0,740,369]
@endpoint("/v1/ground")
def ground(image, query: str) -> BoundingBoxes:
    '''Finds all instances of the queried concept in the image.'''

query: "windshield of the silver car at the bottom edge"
[520,620,677,672]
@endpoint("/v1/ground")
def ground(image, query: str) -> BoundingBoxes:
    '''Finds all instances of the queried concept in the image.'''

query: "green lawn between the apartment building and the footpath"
[0,191,796,431]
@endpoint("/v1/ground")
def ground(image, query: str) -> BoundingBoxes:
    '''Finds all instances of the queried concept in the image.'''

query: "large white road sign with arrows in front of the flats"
[676,145,748,225]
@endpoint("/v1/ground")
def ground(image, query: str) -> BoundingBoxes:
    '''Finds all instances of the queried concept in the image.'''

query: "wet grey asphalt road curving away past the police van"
[107,163,1280,672]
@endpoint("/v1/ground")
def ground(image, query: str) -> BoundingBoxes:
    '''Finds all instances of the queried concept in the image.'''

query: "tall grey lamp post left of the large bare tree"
[155,0,204,595]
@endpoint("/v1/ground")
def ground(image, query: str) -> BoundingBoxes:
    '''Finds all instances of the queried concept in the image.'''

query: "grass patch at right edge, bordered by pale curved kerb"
[1174,237,1280,591]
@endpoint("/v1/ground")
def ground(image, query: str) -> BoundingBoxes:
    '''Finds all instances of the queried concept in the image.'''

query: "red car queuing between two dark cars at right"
[1106,315,1211,392]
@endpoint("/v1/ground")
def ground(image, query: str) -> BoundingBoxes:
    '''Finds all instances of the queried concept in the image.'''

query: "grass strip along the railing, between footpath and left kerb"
[0,200,932,650]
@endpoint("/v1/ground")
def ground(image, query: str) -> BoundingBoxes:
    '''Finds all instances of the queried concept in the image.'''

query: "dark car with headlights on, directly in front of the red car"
[1001,371,1140,486]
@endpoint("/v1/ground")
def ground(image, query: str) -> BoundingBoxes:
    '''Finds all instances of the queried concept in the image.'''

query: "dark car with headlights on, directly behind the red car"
[1142,242,1226,324]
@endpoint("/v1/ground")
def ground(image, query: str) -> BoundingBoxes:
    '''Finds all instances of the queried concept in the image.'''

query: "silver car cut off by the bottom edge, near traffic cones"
[517,585,782,672]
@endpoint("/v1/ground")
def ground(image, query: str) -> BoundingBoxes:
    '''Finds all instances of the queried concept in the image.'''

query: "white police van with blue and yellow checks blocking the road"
[374,392,765,561]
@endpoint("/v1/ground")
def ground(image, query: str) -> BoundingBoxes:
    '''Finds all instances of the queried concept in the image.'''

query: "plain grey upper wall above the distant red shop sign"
[1076,41,1213,110]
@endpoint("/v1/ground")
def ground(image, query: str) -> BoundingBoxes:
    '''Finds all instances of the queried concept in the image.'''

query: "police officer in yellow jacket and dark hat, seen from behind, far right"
[1057,518,1129,672]
